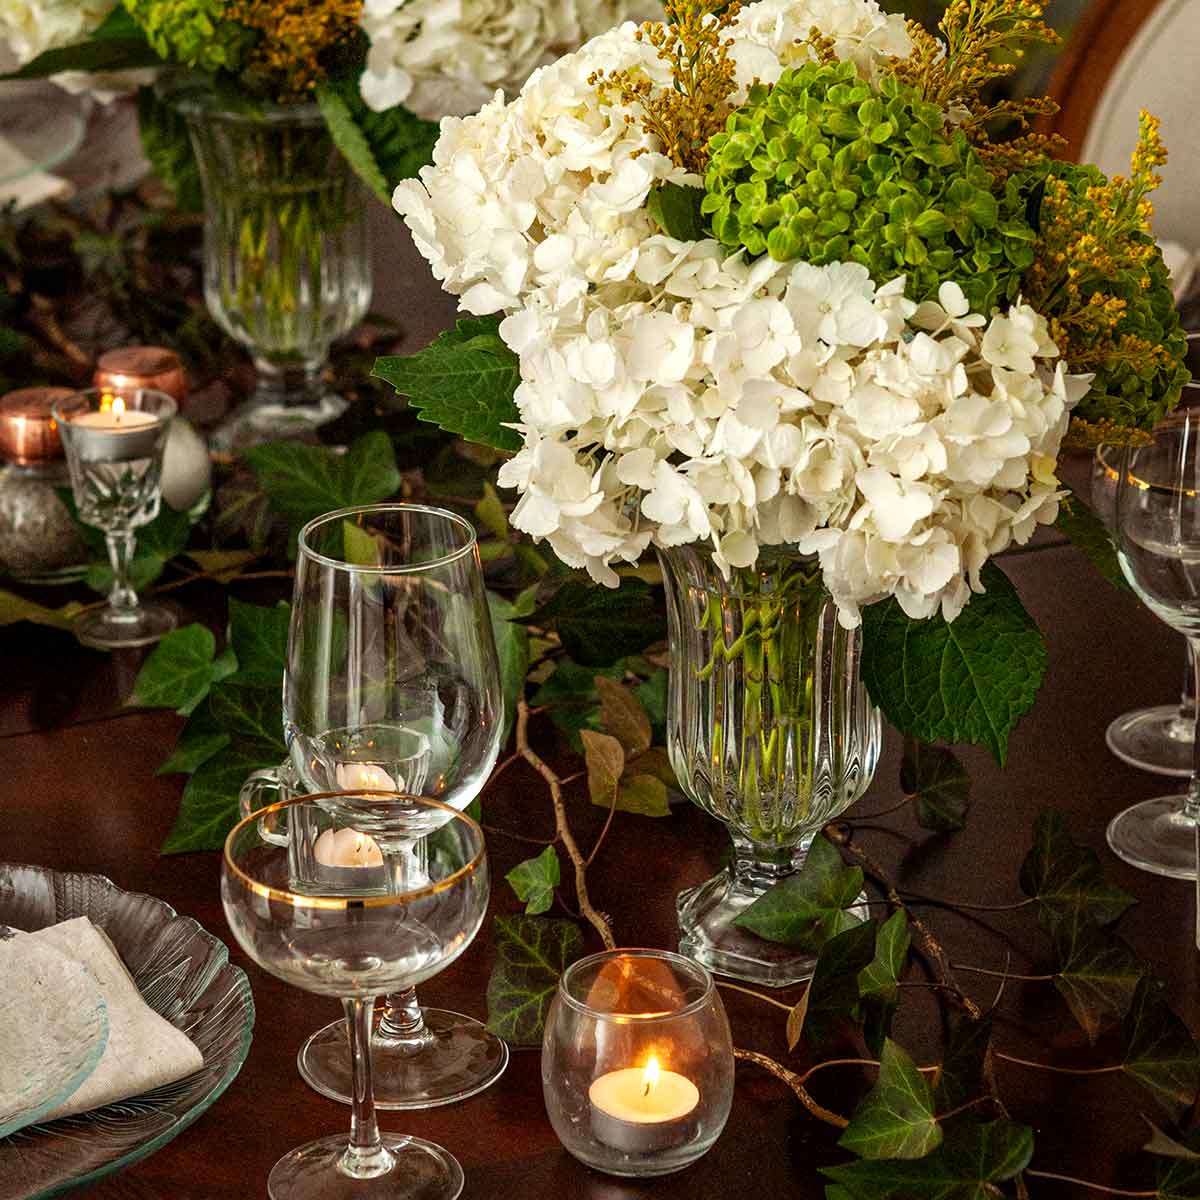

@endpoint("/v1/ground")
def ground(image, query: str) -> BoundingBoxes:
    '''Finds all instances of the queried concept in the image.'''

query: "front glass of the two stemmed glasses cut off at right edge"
[1108,412,1200,878]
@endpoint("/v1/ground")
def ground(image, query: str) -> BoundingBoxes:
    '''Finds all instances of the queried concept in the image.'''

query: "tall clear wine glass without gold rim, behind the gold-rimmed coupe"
[283,504,509,1109]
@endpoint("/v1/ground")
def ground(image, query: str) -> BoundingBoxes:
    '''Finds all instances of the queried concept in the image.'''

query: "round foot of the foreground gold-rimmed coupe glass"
[266,1133,463,1200]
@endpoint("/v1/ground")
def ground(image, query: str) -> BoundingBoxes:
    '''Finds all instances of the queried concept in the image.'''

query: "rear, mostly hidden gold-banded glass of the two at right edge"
[1092,445,1195,779]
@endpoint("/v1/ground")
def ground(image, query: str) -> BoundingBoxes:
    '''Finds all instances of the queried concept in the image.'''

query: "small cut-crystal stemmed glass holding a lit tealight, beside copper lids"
[53,388,176,650]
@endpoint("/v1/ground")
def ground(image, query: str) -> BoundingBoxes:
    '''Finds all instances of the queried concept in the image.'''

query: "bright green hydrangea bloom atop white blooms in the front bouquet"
[701,62,1034,313]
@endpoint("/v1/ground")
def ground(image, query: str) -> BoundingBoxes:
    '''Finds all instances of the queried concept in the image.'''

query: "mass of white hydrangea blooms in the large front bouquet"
[394,0,1087,626]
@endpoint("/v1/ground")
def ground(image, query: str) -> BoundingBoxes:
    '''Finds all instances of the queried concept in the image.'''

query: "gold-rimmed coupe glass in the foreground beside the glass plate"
[221,792,488,1200]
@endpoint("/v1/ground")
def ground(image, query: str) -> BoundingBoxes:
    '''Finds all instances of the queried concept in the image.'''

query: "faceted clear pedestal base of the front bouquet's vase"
[676,869,868,988]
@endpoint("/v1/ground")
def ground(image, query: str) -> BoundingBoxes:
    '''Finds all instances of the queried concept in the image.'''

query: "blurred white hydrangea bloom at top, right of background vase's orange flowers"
[359,0,662,120]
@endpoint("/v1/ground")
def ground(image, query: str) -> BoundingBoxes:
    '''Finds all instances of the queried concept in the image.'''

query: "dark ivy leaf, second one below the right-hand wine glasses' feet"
[1054,912,1144,1044]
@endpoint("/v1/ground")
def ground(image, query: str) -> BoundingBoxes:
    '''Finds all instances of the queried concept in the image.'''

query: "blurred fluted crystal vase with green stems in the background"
[170,88,371,446]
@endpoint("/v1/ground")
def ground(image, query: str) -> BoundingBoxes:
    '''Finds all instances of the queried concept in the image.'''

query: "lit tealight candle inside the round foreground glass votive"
[588,1055,700,1154]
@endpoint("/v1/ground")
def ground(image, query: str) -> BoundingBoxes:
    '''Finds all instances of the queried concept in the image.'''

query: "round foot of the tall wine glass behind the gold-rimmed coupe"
[296,1008,509,1110]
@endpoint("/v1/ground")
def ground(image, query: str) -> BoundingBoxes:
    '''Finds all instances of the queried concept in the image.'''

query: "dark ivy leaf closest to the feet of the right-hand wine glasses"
[1020,808,1136,928]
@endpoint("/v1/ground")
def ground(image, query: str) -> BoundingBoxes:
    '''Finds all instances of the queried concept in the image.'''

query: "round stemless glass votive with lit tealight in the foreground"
[541,949,733,1178]
